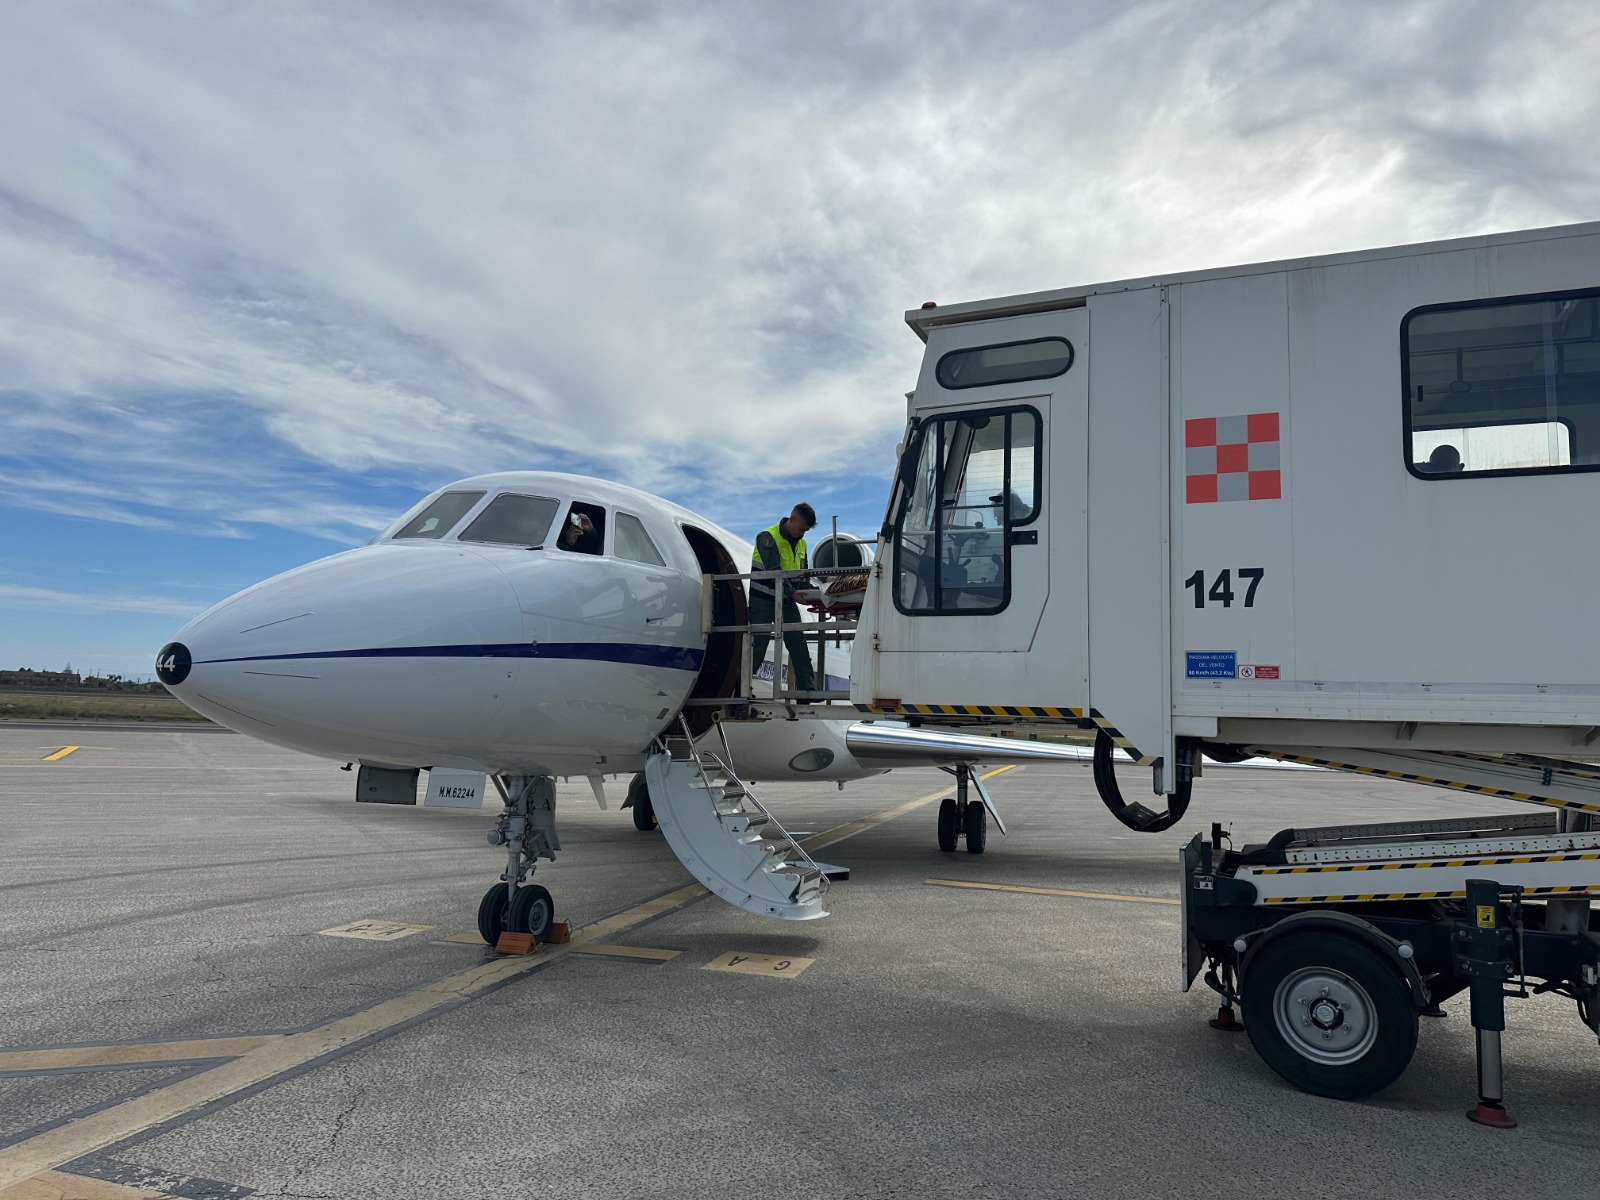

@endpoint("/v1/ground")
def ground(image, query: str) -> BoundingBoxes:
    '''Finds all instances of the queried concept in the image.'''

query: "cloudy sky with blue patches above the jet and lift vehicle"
[0,0,1600,675]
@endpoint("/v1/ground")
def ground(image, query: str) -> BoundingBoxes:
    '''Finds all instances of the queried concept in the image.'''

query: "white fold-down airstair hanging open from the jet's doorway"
[645,726,827,922]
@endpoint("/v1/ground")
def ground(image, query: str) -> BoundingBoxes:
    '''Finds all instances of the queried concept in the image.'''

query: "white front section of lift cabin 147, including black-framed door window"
[862,309,1088,706]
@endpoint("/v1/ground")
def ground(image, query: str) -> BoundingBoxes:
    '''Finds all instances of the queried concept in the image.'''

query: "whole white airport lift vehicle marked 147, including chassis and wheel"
[851,224,1600,1125]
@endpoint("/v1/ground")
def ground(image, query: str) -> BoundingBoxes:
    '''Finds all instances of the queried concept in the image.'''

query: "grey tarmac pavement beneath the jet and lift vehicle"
[0,723,1600,1200]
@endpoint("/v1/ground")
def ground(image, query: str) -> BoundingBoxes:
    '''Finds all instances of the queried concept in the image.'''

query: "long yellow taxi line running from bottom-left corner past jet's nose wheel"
[0,784,947,1200]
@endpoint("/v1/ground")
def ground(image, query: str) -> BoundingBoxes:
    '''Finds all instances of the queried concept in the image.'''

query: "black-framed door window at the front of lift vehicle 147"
[894,408,1040,614]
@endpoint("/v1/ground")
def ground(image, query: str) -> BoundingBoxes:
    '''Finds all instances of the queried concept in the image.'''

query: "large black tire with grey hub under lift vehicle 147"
[1242,930,1416,1099]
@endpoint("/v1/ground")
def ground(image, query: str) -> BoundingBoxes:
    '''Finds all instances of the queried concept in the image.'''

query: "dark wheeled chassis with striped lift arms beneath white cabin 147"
[1181,746,1600,1128]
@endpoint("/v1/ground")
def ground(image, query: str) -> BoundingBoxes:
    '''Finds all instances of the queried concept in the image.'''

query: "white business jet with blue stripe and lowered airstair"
[157,472,1088,944]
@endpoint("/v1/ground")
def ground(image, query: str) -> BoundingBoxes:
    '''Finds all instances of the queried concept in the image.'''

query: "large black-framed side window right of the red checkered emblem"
[1400,290,1600,480]
